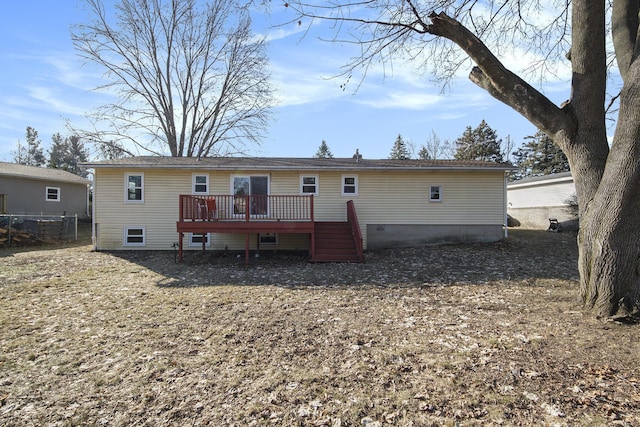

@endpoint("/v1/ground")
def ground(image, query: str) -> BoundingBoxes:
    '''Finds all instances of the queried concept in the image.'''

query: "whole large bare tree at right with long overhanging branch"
[286,0,640,317]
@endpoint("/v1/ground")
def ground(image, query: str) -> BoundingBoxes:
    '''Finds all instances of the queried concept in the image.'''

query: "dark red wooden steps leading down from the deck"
[312,221,363,262]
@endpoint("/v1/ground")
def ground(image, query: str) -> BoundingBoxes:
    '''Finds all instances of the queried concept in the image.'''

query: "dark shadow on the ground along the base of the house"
[102,230,578,288]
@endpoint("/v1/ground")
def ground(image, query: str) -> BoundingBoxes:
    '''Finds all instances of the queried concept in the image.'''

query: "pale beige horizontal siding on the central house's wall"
[94,168,505,250]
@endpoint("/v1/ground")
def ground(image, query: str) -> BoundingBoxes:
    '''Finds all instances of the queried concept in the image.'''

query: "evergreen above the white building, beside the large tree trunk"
[513,131,569,179]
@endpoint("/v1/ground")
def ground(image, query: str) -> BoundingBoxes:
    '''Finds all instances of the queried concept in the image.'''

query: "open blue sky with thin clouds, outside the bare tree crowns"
[0,0,569,161]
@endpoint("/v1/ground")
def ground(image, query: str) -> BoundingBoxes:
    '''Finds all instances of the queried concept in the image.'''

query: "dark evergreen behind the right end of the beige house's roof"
[453,120,504,163]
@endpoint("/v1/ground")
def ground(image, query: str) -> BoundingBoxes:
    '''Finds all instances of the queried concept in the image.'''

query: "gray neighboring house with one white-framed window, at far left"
[0,162,91,218]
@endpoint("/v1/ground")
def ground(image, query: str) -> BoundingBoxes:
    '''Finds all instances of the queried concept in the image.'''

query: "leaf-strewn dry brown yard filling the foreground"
[0,230,640,427]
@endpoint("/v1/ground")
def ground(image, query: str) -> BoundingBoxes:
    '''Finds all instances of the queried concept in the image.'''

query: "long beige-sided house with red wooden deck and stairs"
[85,157,511,261]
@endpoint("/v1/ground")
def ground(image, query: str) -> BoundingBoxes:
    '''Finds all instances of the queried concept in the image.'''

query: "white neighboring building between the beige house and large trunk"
[507,172,577,229]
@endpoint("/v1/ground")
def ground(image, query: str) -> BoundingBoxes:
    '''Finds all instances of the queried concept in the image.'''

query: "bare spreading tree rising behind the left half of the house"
[72,0,273,157]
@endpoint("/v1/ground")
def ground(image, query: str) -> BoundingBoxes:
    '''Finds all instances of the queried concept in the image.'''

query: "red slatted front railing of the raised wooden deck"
[180,195,313,222]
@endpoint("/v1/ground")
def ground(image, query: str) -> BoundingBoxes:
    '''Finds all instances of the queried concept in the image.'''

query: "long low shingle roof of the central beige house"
[83,156,513,171]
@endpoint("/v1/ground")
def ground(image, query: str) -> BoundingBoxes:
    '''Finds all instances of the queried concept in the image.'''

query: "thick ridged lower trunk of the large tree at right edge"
[578,60,640,317]
